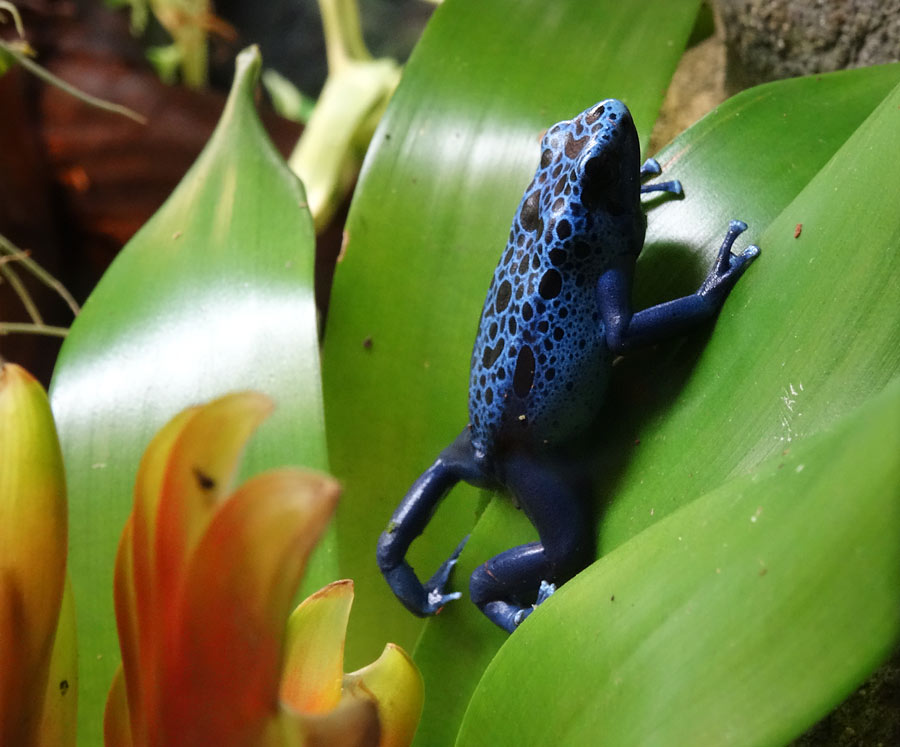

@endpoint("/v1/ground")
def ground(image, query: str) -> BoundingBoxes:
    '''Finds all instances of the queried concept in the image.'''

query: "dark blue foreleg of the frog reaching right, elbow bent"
[597,220,759,353]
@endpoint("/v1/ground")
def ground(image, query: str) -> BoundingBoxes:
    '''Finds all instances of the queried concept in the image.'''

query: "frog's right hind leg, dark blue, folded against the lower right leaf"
[469,453,592,632]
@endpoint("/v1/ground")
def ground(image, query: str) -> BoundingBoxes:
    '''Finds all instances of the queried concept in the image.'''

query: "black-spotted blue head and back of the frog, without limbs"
[469,101,644,452]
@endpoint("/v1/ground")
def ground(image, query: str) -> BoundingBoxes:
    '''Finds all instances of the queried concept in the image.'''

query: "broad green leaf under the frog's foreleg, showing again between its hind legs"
[415,65,900,744]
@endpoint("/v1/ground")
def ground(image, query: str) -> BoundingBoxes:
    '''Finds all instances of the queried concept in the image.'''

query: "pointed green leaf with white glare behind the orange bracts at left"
[52,49,335,744]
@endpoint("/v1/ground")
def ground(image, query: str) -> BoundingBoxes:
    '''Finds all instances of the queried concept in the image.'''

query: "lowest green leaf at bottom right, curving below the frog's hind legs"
[457,378,900,745]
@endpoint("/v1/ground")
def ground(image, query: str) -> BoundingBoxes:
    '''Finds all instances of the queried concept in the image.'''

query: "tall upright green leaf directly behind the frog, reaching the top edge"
[323,0,698,672]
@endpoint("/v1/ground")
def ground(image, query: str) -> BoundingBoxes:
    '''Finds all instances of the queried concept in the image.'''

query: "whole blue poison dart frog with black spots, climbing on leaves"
[378,99,759,632]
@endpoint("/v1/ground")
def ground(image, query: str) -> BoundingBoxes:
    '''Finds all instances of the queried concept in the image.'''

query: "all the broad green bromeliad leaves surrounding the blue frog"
[28,0,900,747]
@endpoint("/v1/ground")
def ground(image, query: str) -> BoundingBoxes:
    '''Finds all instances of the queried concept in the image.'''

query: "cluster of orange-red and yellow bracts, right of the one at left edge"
[104,393,422,747]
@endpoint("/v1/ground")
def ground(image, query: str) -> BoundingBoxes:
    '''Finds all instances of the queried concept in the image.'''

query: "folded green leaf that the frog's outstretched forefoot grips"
[599,65,900,554]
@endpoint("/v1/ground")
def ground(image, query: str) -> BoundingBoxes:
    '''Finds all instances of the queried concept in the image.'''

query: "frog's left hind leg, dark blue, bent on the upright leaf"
[377,431,485,617]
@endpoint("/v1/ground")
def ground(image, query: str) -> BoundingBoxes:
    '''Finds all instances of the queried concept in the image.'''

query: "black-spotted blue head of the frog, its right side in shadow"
[541,99,641,217]
